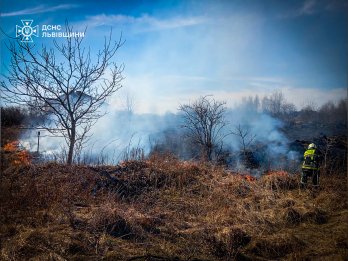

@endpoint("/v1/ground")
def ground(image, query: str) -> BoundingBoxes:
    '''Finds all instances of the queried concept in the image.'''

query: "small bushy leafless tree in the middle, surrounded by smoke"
[179,96,226,161]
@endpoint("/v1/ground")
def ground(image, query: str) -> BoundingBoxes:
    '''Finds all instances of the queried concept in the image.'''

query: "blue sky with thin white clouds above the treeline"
[0,0,348,113]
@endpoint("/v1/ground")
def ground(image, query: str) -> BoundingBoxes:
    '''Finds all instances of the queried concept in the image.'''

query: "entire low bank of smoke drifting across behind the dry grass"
[21,97,298,172]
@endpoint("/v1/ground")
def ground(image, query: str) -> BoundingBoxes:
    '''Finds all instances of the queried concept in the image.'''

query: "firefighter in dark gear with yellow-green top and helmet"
[301,143,321,188]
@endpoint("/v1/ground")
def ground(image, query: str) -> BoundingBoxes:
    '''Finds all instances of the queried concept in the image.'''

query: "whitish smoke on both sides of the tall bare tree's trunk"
[21,105,180,163]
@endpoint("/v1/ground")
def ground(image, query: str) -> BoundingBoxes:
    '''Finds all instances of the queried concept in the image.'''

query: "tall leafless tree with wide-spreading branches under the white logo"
[1,23,124,164]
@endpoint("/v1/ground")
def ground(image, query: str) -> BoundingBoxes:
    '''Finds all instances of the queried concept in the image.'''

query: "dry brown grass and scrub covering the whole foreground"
[0,152,348,261]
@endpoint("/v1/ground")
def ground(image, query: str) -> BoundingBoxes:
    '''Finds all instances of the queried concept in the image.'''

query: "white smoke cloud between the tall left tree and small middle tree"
[82,110,179,160]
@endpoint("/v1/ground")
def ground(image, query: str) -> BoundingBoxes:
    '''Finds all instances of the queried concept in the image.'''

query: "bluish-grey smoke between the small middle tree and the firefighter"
[224,104,299,170]
